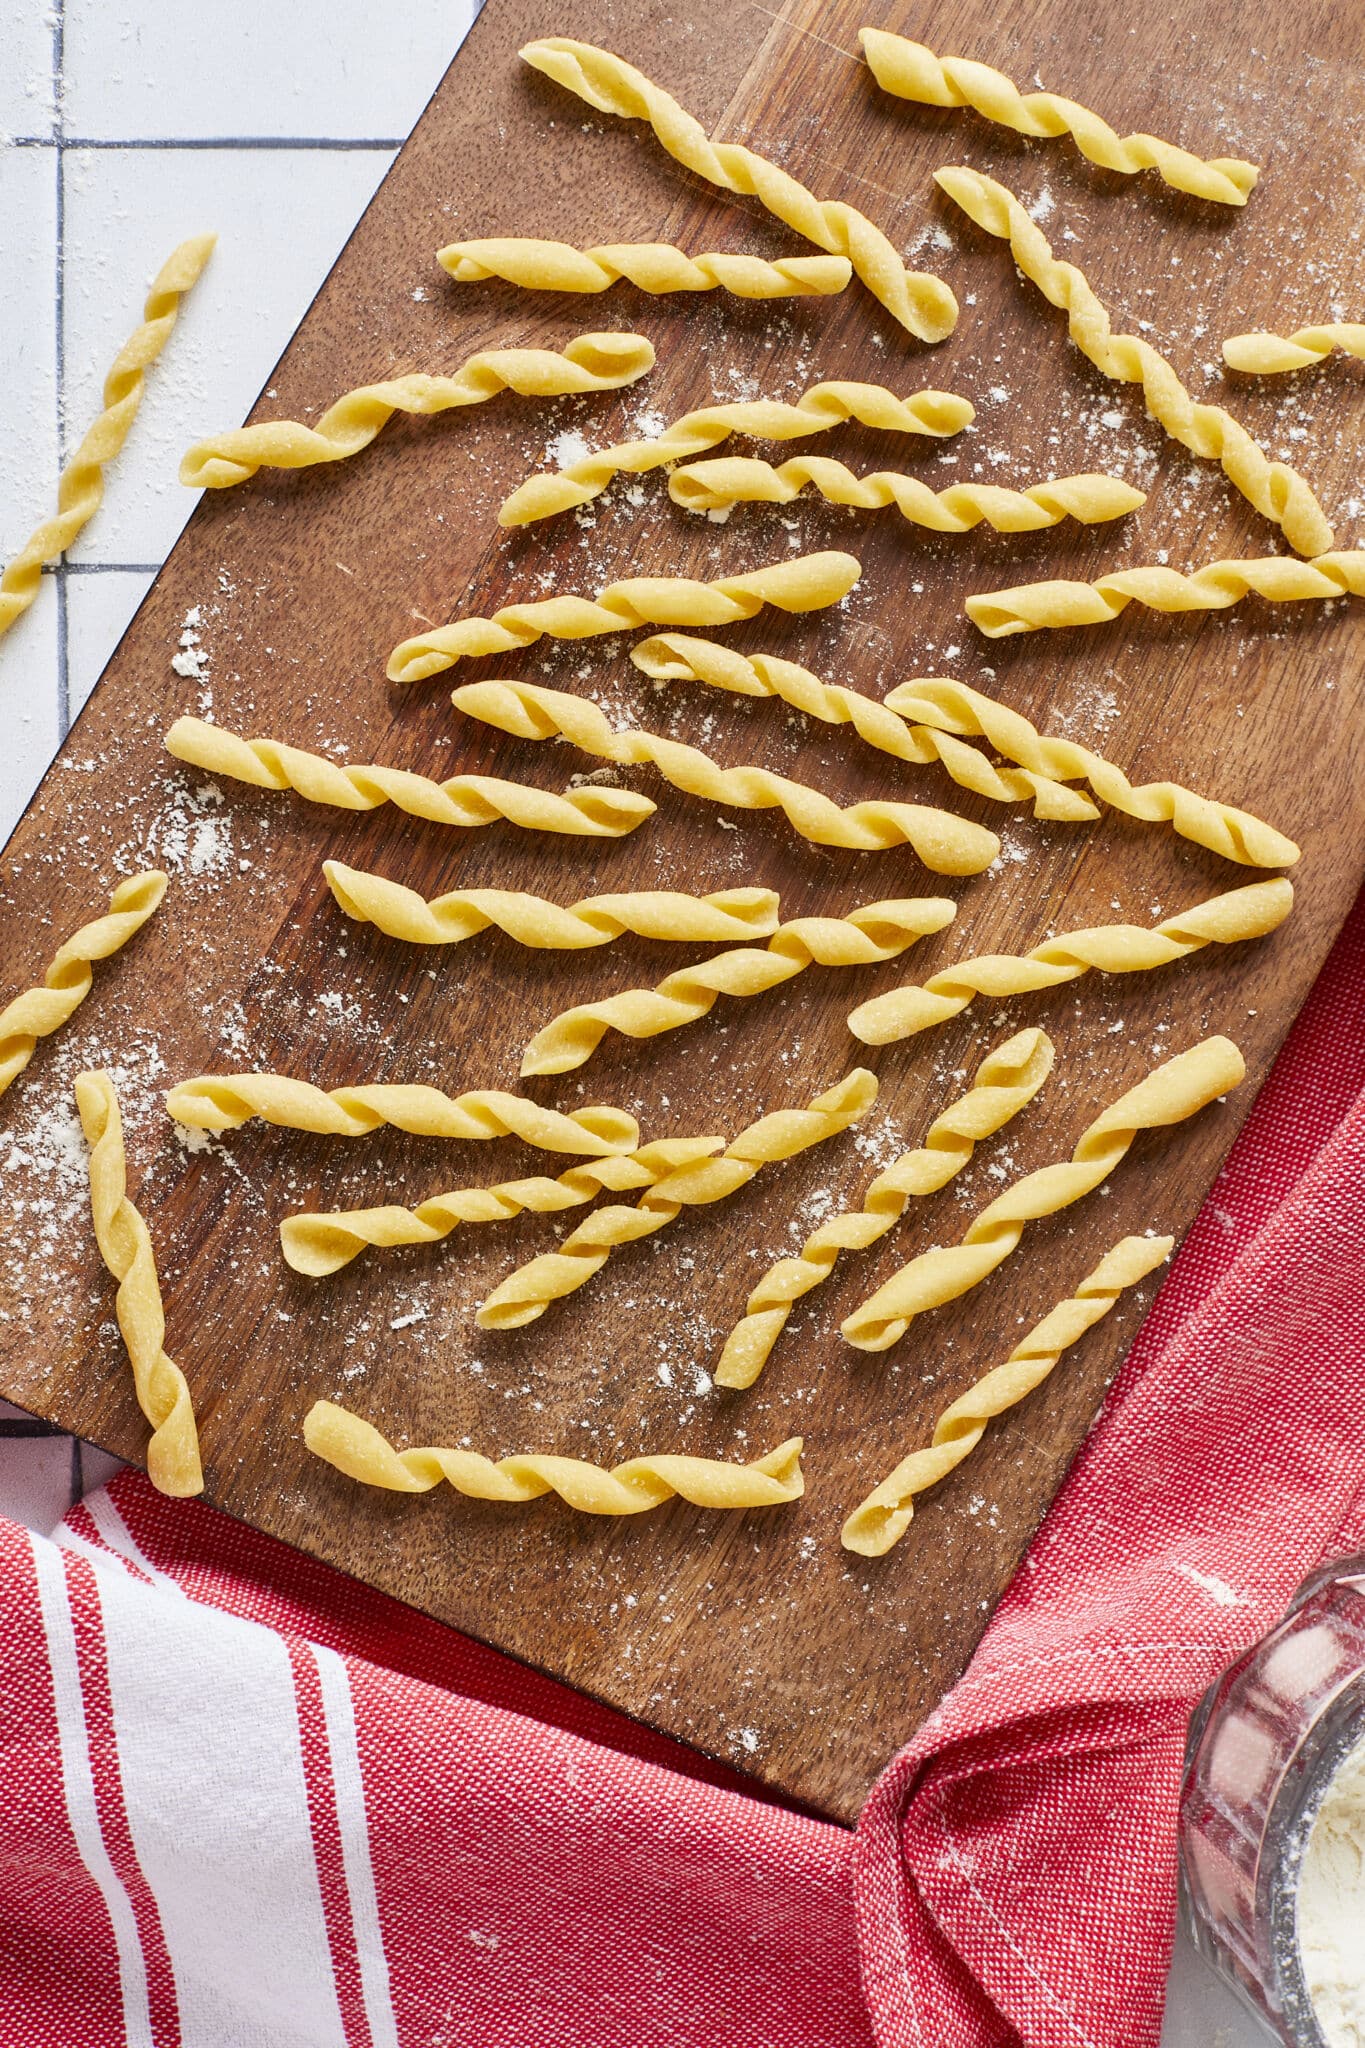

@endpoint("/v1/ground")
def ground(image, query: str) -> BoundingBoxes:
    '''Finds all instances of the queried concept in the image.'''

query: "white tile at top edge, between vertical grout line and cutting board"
[65,0,467,139]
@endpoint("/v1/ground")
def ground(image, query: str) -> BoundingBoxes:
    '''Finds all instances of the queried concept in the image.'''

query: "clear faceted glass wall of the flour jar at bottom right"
[1181,1554,1365,2048]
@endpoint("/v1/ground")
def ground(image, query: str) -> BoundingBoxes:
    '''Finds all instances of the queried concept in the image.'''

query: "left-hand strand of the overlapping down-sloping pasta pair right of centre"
[630,633,1099,823]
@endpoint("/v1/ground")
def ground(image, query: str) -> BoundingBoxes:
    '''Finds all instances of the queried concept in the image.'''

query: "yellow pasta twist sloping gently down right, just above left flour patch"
[166,719,657,840]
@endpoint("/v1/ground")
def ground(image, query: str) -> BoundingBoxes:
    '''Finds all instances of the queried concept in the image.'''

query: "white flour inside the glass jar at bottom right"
[1300,1743,1365,2048]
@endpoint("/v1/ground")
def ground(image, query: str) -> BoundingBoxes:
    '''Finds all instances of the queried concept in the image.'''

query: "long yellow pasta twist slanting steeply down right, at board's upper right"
[933,168,1332,555]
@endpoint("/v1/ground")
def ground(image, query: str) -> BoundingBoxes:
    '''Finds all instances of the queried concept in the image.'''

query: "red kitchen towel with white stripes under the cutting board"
[0,884,1365,2048]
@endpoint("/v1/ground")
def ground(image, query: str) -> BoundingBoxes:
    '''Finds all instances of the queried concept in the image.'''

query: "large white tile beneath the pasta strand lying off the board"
[63,150,393,563]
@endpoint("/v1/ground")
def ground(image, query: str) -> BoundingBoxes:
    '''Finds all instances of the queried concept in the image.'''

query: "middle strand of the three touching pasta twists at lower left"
[280,1137,724,1280]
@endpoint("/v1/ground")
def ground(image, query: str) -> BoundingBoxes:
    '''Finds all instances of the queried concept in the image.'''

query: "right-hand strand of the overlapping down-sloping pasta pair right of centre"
[879,671,1300,868]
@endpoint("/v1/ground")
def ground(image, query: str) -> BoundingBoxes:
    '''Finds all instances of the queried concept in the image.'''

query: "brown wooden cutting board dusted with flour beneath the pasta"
[0,0,1365,1819]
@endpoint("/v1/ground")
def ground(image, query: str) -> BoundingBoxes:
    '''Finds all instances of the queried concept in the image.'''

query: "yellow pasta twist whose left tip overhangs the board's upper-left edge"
[180,334,655,492]
